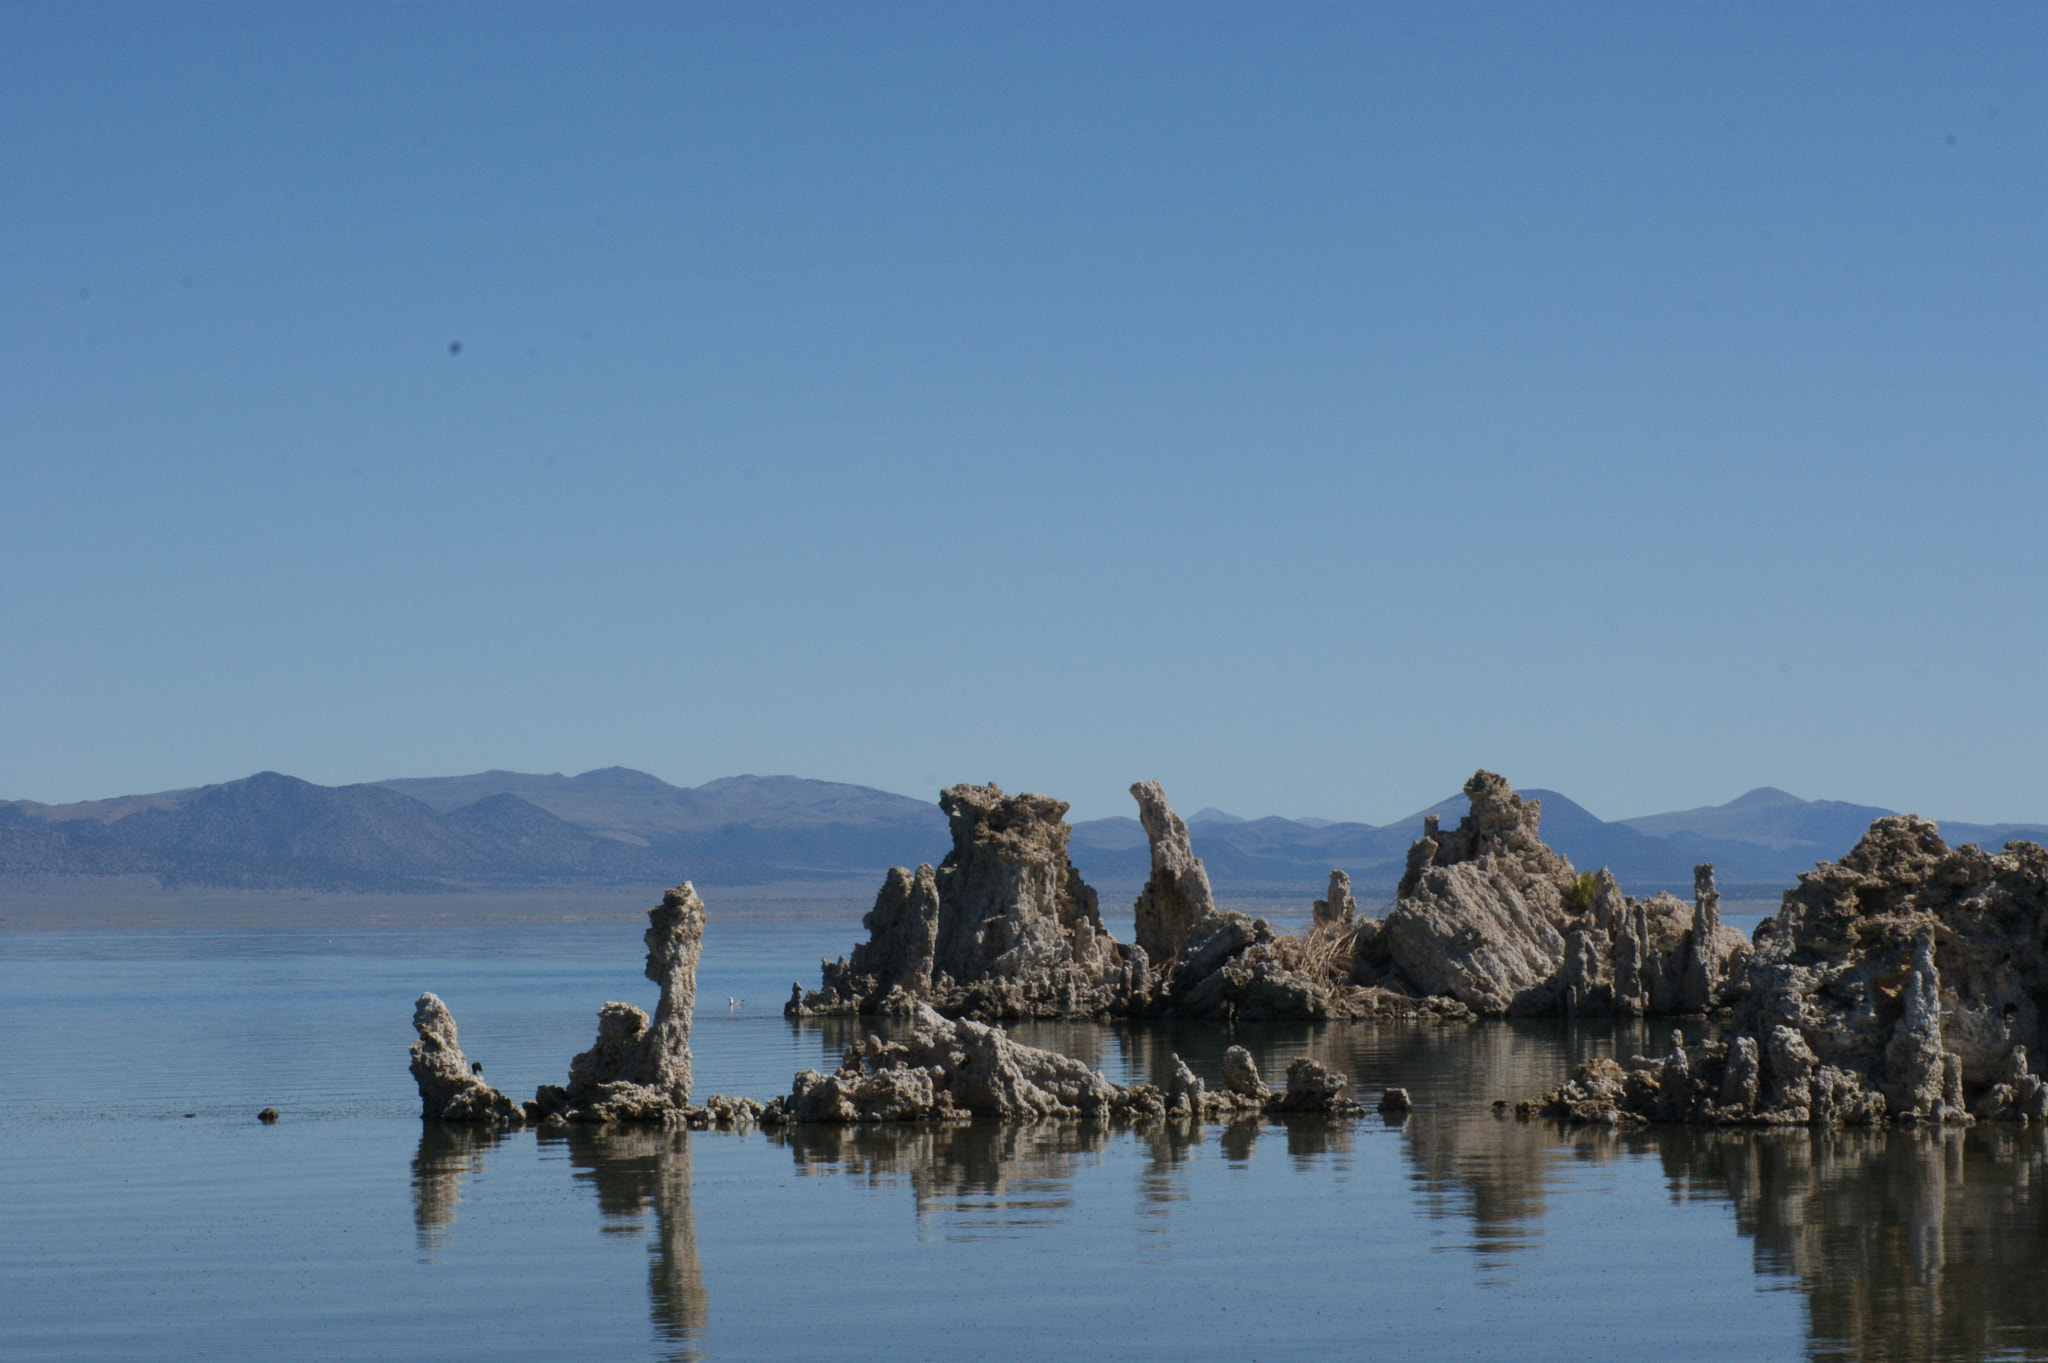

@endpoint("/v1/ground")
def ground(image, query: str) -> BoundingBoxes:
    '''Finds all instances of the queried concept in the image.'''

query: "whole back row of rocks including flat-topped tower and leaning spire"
[784,772,1747,1021]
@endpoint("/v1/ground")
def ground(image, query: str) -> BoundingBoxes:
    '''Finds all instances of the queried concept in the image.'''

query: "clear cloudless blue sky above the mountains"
[0,0,2048,823]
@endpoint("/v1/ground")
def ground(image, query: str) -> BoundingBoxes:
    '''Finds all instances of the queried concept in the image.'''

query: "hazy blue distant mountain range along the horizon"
[0,767,2048,898]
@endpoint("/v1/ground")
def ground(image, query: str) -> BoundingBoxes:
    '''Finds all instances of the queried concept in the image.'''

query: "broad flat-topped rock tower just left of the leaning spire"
[784,784,1155,1017]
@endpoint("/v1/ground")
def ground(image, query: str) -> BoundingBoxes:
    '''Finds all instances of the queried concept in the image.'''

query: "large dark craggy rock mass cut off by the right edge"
[1520,815,2048,1126]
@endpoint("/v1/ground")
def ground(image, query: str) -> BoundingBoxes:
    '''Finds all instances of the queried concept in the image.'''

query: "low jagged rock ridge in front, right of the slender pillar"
[770,1007,1358,1124]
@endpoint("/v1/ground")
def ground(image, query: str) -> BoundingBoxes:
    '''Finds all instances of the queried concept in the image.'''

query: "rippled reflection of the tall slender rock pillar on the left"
[539,1126,709,1361]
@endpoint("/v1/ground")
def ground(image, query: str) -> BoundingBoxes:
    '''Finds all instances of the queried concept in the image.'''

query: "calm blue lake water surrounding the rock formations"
[0,921,2048,1361]
